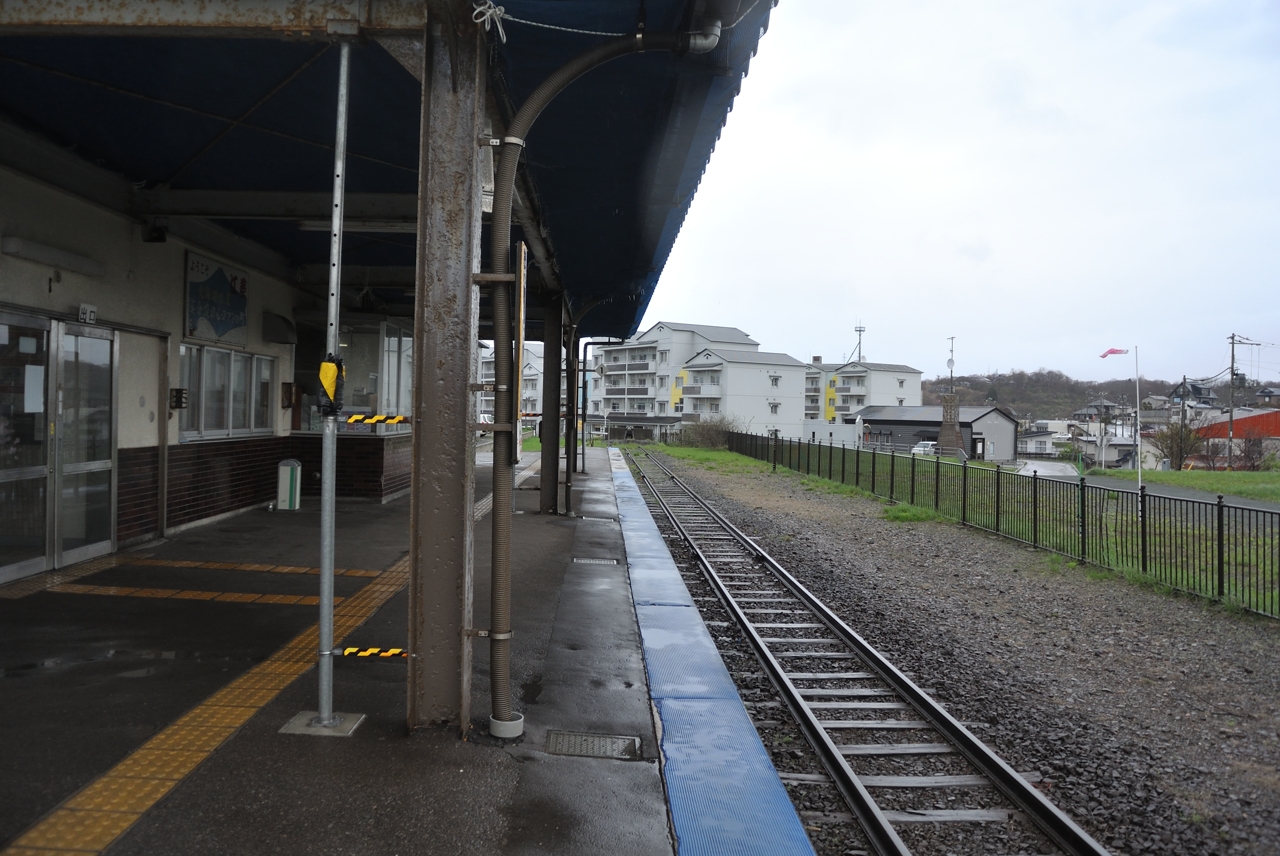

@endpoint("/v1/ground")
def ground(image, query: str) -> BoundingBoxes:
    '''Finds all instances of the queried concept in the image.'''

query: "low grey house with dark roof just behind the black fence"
[833,404,1018,462]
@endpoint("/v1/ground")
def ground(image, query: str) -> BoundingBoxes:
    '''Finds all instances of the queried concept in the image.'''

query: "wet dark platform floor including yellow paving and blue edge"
[0,449,812,856]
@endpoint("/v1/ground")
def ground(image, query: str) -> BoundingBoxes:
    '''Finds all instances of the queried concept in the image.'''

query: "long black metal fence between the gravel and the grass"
[728,432,1280,618]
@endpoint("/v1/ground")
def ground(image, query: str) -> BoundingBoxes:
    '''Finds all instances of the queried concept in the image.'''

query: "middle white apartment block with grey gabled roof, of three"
[671,348,806,436]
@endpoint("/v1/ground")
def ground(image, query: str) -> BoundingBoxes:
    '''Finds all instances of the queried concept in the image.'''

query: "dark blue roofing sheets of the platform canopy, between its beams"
[0,0,772,337]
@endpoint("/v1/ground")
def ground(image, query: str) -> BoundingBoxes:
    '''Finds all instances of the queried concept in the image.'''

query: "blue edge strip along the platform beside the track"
[609,449,813,856]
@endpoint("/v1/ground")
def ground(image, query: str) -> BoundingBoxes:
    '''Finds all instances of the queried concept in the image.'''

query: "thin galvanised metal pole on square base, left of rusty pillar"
[312,42,351,728]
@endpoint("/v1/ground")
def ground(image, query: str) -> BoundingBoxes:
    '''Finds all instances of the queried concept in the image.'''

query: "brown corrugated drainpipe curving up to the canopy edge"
[489,20,721,737]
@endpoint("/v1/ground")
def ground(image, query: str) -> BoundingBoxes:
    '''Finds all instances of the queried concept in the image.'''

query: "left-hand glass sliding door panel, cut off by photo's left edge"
[0,312,52,585]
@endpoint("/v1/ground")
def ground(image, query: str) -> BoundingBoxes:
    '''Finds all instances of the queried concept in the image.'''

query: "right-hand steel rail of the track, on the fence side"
[637,453,1110,856]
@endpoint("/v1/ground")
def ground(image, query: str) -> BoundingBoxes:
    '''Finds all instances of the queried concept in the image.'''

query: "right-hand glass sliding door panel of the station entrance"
[54,324,116,567]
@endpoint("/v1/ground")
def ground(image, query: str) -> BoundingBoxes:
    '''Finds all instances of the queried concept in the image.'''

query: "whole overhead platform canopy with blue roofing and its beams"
[0,0,773,337]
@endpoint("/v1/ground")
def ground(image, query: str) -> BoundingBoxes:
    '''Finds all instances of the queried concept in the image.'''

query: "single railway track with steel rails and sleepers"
[628,454,1107,856]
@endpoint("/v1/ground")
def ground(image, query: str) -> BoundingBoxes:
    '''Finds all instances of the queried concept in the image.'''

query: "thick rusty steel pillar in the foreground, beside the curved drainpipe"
[407,15,483,736]
